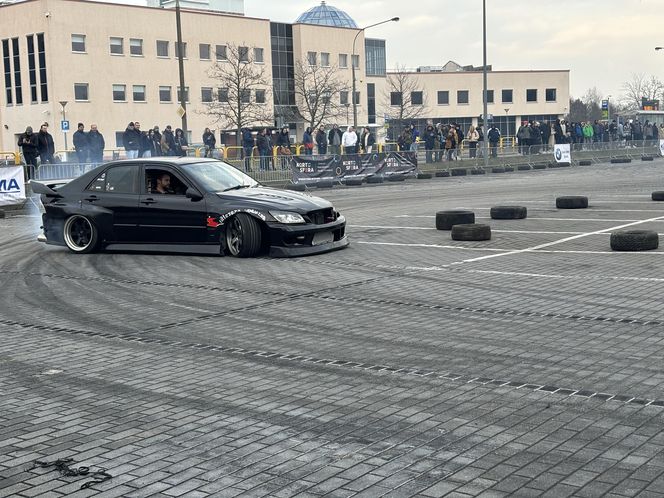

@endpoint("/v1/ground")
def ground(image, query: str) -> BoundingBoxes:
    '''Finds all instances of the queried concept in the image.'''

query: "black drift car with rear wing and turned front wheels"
[31,158,348,258]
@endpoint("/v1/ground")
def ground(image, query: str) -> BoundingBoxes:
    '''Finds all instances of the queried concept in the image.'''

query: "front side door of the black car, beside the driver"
[139,164,207,244]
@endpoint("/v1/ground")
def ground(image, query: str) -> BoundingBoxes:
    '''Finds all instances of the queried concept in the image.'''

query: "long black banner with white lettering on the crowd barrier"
[290,152,417,183]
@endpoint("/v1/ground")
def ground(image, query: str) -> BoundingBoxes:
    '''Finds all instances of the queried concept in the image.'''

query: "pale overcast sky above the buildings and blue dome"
[102,0,664,98]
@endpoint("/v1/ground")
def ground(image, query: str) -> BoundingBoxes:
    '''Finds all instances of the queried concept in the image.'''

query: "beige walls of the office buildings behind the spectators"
[0,0,569,155]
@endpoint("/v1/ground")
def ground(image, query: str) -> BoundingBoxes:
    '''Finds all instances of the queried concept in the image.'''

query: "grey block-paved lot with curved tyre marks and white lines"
[0,159,664,497]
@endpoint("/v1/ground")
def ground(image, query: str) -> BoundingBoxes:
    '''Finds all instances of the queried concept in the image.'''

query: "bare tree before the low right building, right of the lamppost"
[384,66,427,128]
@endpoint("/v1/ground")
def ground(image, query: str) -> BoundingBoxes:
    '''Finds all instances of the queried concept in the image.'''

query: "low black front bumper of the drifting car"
[267,216,350,258]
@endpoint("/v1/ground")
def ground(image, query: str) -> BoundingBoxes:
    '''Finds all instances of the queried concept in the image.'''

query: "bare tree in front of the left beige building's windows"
[205,44,273,145]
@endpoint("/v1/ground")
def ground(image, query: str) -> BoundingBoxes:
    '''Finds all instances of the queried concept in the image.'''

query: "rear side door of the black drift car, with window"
[81,163,140,242]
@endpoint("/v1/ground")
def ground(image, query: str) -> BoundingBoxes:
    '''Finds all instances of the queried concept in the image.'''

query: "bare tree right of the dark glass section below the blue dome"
[294,60,349,129]
